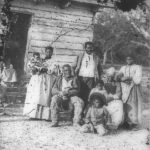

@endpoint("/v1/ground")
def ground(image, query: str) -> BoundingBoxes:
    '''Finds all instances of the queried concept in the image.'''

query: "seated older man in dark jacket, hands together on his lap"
[51,64,84,127]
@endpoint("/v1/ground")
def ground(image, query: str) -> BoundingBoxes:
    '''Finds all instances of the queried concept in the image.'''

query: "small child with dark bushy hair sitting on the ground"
[81,94,107,136]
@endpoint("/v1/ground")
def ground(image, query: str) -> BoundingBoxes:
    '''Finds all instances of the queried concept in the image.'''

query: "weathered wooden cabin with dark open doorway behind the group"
[0,0,97,75]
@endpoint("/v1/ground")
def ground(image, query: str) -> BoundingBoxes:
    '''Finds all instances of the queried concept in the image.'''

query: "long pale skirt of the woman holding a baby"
[23,74,54,120]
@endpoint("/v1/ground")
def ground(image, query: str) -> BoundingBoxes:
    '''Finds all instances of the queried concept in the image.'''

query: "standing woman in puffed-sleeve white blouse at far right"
[119,56,143,129]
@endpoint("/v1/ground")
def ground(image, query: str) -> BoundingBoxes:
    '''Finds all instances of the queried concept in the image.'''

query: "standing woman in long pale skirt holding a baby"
[23,47,59,120]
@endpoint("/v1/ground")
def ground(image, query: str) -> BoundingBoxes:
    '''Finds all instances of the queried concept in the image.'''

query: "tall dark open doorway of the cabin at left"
[5,13,31,78]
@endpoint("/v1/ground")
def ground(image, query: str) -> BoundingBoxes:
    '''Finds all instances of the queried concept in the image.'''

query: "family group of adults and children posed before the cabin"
[23,42,142,135]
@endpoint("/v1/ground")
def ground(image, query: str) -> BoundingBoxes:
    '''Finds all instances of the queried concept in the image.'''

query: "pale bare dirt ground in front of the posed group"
[0,116,150,150]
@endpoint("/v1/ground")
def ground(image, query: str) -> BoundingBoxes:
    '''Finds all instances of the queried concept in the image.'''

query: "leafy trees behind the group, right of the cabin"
[94,7,150,65]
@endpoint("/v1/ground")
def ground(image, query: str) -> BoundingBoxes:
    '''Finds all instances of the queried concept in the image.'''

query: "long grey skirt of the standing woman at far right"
[124,85,143,124]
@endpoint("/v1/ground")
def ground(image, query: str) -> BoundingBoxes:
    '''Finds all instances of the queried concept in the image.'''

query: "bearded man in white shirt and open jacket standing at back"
[75,42,102,104]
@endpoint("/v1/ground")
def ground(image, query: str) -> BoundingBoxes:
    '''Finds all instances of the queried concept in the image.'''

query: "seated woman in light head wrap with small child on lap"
[89,68,124,129]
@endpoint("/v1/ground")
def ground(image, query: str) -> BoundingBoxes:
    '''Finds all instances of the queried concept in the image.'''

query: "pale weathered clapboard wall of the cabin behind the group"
[0,0,93,69]
